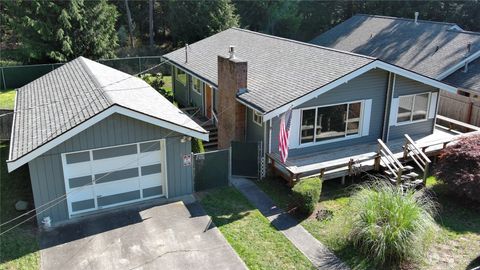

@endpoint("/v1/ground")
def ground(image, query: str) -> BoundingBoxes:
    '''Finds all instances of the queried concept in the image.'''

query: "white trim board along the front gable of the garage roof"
[7,105,208,172]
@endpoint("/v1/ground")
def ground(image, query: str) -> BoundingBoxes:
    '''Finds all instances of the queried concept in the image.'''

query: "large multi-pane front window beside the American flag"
[300,102,362,144]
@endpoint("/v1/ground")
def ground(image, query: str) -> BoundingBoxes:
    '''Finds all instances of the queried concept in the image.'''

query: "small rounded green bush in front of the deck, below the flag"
[292,177,322,215]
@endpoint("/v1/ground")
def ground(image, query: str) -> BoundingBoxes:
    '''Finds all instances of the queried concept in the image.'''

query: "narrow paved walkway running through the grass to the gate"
[232,178,348,270]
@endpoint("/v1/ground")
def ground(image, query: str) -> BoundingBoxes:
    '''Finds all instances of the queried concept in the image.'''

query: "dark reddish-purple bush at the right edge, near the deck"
[435,135,480,202]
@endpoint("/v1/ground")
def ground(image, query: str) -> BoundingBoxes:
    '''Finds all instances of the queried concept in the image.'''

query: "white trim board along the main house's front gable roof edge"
[262,60,457,122]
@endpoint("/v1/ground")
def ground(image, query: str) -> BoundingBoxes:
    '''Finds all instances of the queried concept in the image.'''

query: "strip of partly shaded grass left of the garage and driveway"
[0,143,40,269]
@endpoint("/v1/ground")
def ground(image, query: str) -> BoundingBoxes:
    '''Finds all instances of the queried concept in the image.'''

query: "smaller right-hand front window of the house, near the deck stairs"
[397,93,430,123]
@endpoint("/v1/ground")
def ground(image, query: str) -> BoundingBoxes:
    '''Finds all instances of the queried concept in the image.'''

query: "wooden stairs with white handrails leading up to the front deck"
[374,135,431,189]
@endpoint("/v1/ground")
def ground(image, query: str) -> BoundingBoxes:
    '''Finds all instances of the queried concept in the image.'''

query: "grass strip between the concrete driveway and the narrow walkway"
[201,188,313,269]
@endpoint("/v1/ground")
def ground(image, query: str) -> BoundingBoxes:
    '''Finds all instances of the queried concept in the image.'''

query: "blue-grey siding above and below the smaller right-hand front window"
[388,75,438,140]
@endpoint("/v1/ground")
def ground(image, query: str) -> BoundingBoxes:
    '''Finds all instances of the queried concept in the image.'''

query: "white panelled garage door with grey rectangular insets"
[62,140,167,217]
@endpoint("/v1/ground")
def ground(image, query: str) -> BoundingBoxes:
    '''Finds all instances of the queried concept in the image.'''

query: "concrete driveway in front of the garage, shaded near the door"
[40,199,246,270]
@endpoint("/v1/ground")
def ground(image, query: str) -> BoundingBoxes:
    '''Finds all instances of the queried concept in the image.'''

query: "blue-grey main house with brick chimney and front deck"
[164,28,464,184]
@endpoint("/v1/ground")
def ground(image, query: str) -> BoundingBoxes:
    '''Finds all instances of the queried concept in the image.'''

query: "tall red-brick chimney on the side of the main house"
[218,46,247,149]
